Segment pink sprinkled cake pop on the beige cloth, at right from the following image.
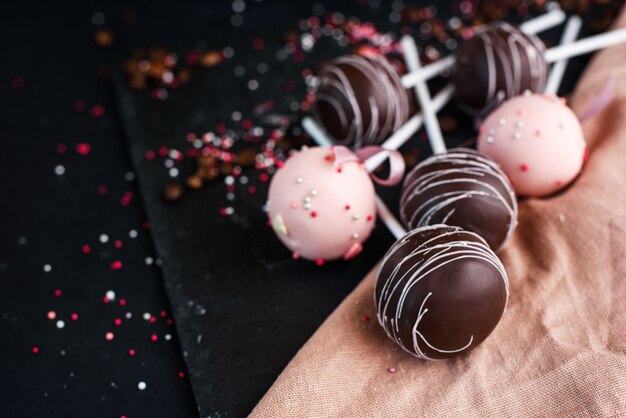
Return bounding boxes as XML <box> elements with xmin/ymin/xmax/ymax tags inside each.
<box><xmin>478</xmin><ymin>94</ymin><xmax>587</xmax><ymax>196</ymax></box>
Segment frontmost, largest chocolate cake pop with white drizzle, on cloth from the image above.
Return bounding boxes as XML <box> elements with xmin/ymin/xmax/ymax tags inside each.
<box><xmin>374</xmin><ymin>225</ymin><xmax>509</xmax><ymax>360</ymax></box>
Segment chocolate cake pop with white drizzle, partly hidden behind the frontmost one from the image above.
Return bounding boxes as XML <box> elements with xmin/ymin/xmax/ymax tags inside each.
<box><xmin>400</xmin><ymin>148</ymin><xmax>517</xmax><ymax>251</ymax></box>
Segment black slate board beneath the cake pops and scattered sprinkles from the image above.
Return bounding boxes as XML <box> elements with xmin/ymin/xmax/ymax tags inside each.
<box><xmin>115</xmin><ymin>2</ymin><xmax>582</xmax><ymax>417</ymax></box>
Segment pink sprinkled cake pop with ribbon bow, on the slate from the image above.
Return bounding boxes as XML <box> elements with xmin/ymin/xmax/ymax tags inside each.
<box><xmin>268</xmin><ymin>147</ymin><xmax>376</xmax><ymax>261</ymax></box>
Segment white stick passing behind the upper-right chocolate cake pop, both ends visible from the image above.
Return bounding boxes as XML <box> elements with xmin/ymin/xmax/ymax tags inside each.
<box><xmin>402</xmin><ymin>8</ymin><xmax>565</xmax><ymax>89</ymax></box>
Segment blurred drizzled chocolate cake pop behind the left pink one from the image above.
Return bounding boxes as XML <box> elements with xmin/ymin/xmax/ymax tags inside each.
<box><xmin>313</xmin><ymin>55</ymin><xmax>412</xmax><ymax>148</ymax></box>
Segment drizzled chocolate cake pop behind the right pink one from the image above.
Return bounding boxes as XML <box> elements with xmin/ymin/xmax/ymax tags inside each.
<box><xmin>452</xmin><ymin>22</ymin><xmax>548</xmax><ymax>116</ymax></box>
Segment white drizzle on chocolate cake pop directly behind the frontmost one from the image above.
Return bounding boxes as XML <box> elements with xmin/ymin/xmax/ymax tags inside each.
<box><xmin>400</xmin><ymin>148</ymin><xmax>518</xmax><ymax>250</ymax></box>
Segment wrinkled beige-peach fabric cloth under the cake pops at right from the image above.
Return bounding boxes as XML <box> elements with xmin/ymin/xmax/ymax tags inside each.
<box><xmin>252</xmin><ymin>12</ymin><xmax>626</xmax><ymax>417</ymax></box>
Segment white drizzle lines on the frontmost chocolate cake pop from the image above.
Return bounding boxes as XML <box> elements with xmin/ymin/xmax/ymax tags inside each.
<box><xmin>375</xmin><ymin>225</ymin><xmax>509</xmax><ymax>360</ymax></box>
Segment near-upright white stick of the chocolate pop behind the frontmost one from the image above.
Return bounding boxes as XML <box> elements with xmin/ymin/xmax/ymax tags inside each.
<box><xmin>400</xmin><ymin>36</ymin><xmax>446</xmax><ymax>154</ymax></box>
